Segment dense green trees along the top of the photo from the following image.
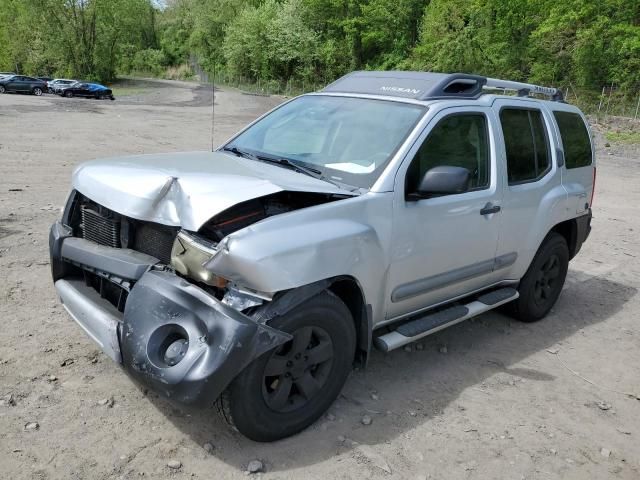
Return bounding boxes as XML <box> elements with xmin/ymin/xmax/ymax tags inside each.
<box><xmin>0</xmin><ymin>0</ymin><xmax>640</xmax><ymax>89</ymax></box>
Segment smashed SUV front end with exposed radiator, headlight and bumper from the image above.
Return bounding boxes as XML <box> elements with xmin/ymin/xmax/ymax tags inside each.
<box><xmin>50</xmin><ymin>192</ymin><xmax>308</xmax><ymax>405</ymax></box>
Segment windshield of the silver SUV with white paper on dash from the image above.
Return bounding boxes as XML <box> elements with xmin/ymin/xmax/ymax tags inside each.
<box><xmin>226</xmin><ymin>95</ymin><xmax>426</xmax><ymax>188</ymax></box>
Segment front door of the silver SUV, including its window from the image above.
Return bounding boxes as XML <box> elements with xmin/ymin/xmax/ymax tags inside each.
<box><xmin>387</xmin><ymin>107</ymin><xmax>510</xmax><ymax>319</ymax></box>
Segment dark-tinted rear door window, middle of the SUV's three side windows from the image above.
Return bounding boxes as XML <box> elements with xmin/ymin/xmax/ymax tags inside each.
<box><xmin>500</xmin><ymin>107</ymin><xmax>551</xmax><ymax>185</ymax></box>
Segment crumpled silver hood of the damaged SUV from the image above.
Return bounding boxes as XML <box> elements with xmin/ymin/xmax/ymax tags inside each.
<box><xmin>73</xmin><ymin>152</ymin><xmax>353</xmax><ymax>231</ymax></box>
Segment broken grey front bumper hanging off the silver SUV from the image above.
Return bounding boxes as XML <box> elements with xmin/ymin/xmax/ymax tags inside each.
<box><xmin>49</xmin><ymin>222</ymin><xmax>291</xmax><ymax>406</ymax></box>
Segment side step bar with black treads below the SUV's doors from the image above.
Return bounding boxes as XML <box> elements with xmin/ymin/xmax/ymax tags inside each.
<box><xmin>373</xmin><ymin>287</ymin><xmax>520</xmax><ymax>352</ymax></box>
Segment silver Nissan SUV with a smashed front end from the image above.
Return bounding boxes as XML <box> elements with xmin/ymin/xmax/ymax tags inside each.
<box><xmin>50</xmin><ymin>72</ymin><xmax>595</xmax><ymax>441</ymax></box>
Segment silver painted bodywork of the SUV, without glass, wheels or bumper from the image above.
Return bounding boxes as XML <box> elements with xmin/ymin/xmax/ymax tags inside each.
<box><xmin>73</xmin><ymin>93</ymin><xmax>595</xmax><ymax>328</ymax></box>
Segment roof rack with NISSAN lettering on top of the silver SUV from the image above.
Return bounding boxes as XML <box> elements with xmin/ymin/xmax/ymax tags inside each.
<box><xmin>322</xmin><ymin>71</ymin><xmax>563</xmax><ymax>101</ymax></box>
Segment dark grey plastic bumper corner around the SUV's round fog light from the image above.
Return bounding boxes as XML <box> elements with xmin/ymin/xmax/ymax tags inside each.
<box><xmin>121</xmin><ymin>270</ymin><xmax>292</xmax><ymax>407</ymax></box>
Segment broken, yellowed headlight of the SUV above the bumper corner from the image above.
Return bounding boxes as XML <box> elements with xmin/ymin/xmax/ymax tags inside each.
<box><xmin>171</xmin><ymin>230</ymin><xmax>227</xmax><ymax>288</ymax></box>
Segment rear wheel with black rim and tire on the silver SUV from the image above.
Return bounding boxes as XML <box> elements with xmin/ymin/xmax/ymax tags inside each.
<box><xmin>511</xmin><ymin>232</ymin><xmax>569</xmax><ymax>322</ymax></box>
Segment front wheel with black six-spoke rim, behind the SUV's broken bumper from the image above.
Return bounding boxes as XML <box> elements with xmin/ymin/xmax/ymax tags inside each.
<box><xmin>217</xmin><ymin>291</ymin><xmax>356</xmax><ymax>442</ymax></box>
